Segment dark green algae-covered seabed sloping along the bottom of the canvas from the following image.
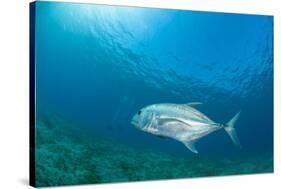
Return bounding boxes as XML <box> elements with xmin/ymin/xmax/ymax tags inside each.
<box><xmin>35</xmin><ymin>115</ymin><xmax>273</xmax><ymax>187</ymax></box>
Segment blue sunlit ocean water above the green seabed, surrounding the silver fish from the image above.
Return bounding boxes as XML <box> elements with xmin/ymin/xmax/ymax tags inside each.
<box><xmin>32</xmin><ymin>2</ymin><xmax>273</xmax><ymax>185</ymax></box>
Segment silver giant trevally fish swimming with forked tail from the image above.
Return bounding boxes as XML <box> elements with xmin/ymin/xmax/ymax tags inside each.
<box><xmin>131</xmin><ymin>102</ymin><xmax>241</xmax><ymax>153</ymax></box>
